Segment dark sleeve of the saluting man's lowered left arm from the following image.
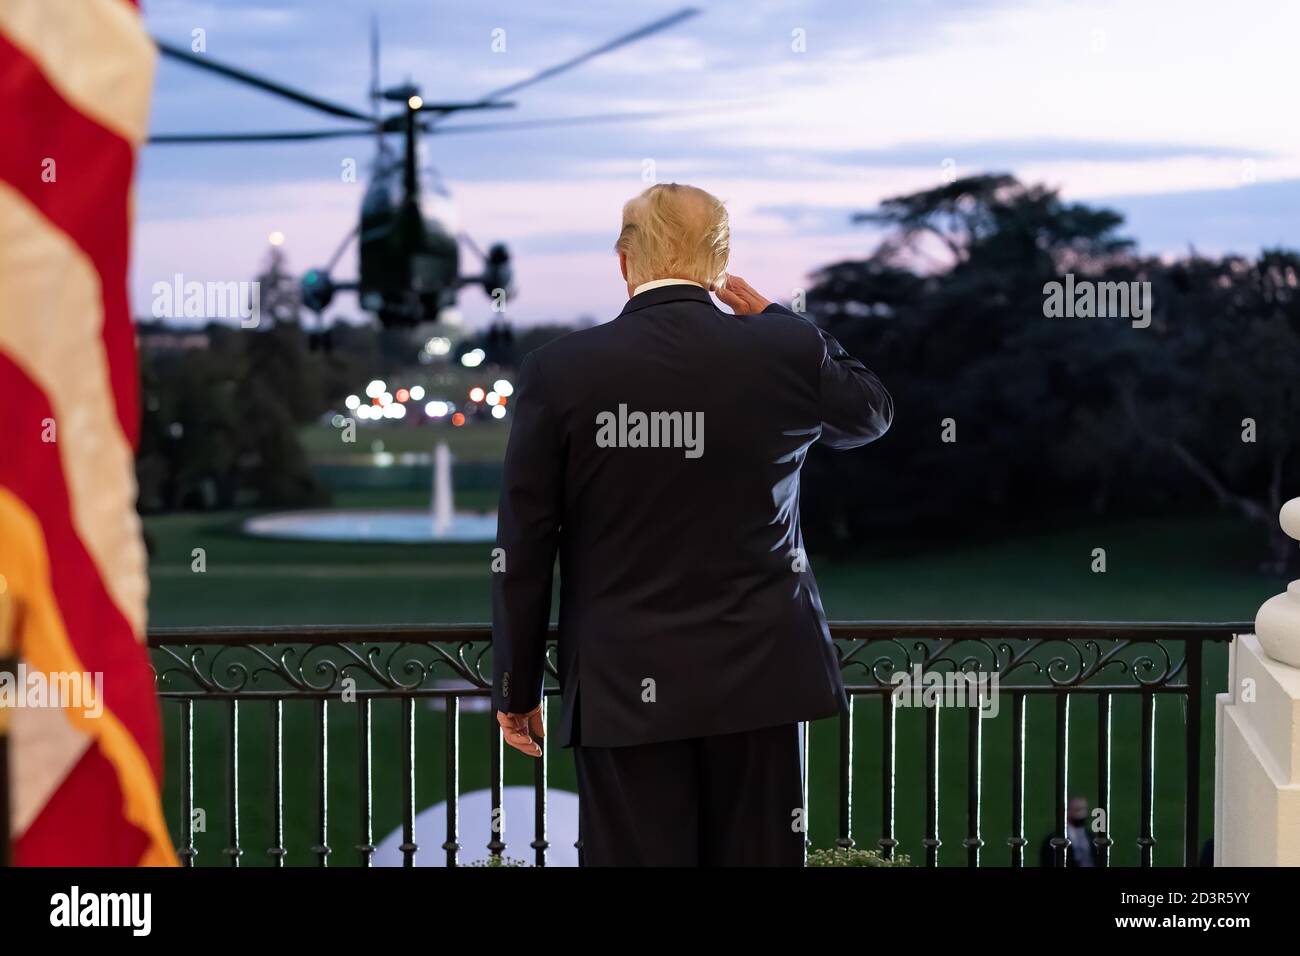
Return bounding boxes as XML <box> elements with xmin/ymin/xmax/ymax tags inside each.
<box><xmin>491</xmin><ymin>354</ymin><xmax>564</xmax><ymax>714</ymax></box>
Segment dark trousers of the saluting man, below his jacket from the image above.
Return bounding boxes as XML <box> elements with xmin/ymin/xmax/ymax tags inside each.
<box><xmin>573</xmin><ymin>723</ymin><xmax>805</xmax><ymax>866</ymax></box>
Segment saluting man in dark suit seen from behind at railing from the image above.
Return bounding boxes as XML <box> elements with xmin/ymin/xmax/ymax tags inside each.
<box><xmin>493</xmin><ymin>183</ymin><xmax>893</xmax><ymax>865</ymax></box>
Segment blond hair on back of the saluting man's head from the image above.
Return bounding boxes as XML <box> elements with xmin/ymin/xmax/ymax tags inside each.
<box><xmin>614</xmin><ymin>182</ymin><xmax>731</xmax><ymax>289</ymax></box>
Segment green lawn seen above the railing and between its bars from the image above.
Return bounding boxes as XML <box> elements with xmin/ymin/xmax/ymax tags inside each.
<box><xmin>146</xmin><ymin>476</ymin><xmax>1282</xmax><ymax>865</ymax></box>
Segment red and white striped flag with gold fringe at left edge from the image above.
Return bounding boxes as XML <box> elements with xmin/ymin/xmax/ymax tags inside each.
<box><xmin>0</xmin><ymin>0</ymin><xmax>176</xmax><ymax>865</ymax></box>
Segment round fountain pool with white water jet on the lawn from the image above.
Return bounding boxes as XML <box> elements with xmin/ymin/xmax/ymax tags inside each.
<box><xmin>243</xmin><ymin>441</ymin><xmax>497</xmax><ymax>544</ymax></box>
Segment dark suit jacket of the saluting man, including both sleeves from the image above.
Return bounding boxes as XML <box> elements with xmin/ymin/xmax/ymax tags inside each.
<box><xmin>493</xmin><ymin>285</ymin><xmax>893</xmax><ymax>747</ymax></box>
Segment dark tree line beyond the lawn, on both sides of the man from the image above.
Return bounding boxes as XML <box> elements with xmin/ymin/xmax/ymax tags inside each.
<box><xmin>138</xmin><ymin>174</ymin><xmax>1300</xmax><ymax>570</ymax></box>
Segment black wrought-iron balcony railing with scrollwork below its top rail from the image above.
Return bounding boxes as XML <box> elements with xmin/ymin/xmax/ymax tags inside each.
<box><xmin>137</xmin><ymin>622</ymin><xmax>1252</xmax><ymax>866</ymax></box>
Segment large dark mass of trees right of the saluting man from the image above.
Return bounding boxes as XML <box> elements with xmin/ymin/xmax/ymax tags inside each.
<box><xmin>803</xmin><ymin>174</ymin><xmax>1300</xmax><ymax>567</ymax></box>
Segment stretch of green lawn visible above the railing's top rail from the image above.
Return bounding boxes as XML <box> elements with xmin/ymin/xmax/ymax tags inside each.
<box><xmin>146</xmin><ymin>512</ymin><xmax>1281</xmax><ymax>626</ymax></box>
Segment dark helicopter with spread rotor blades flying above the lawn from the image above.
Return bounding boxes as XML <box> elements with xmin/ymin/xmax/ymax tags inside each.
<box><xmin>148</xmin><ymin>7</ymin><xmax>699</xmax><ymax>328</ymax></box>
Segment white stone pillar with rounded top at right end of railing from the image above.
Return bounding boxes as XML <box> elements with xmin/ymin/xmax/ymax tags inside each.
<box><xmin>1214</xmin><ymin>498</ymin><xmax>1300</xmax><ymax>866</ymax></box>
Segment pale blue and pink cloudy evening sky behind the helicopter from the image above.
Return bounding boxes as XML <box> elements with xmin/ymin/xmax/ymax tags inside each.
<box><xmin>131</xmin><ymin>0</ymin><xmax>1300</xmax><ymax>329</ymax></box>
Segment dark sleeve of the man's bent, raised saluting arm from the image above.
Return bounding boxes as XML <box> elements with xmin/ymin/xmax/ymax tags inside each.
<box><xmin>764</xmin><ymin>302</ymin><xmax>893</xmax><ymax>449</ymax></box>
